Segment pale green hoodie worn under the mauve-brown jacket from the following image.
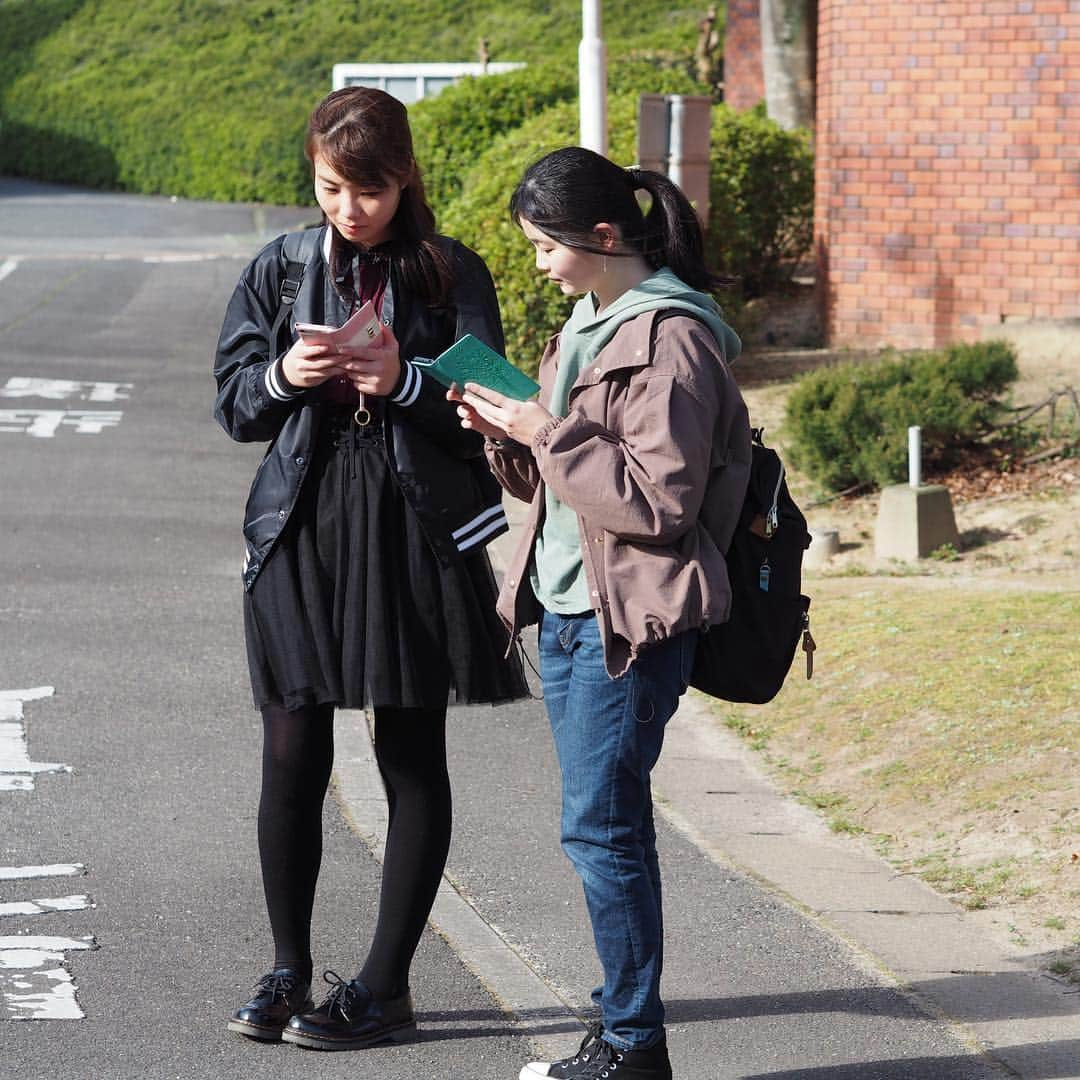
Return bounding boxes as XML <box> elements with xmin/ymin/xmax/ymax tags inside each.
<box><xmin>529</xmin><ymin>267</ymin><xmax>742</xmax><ymax>615</ymax></box>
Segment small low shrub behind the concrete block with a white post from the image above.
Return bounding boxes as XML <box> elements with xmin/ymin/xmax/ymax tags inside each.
<box><xmin>786</xmin><ymin>341</ymin><xmax>1017</xmax><ymax>490</ymax></box>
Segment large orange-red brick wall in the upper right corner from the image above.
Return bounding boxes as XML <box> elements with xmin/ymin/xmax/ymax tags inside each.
<box><xmin>816</xmin><ymin>0</ymin><xmax>1080</xmax><ymax>348</ymax></box>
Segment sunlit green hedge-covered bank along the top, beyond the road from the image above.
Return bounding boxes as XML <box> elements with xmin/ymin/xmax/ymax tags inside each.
<box><xmin>0</xmin><ymin>0</ymin><xmax>700</xmax><ymax>203</ymax></box>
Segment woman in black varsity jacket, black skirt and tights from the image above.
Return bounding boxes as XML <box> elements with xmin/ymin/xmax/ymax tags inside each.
<box><xmin>214</xmin><ymin>86</ymin><xmax>527</xmax><ymax>1050</ymax></box>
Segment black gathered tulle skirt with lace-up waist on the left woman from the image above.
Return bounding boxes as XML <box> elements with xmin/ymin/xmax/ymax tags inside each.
<box><xmin>244</xmin><ymin>253</ymin><xmax>528</xmax><ymax>710</ymax></box>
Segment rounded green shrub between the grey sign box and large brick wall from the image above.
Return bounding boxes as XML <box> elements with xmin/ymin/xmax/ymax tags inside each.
<box><xmin>708</xmin><ymin>105</ymin><xmax>813</xmax><ymax>297</ymax></box>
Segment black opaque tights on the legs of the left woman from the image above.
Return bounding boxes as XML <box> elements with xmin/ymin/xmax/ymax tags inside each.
<box><xmin>258</xmin><ymin>705</ymin><xmax>450</xmax><ymax>999</ymax></box>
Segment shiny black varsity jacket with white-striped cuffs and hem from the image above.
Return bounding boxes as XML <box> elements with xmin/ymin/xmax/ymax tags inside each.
<box><xmin>214</xmin><ymin>227</ymin><xmax>509</xmax><ymax>589</ymax></box>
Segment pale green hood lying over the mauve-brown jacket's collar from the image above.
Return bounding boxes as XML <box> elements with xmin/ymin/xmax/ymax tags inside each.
<box><xmin>565</xmin><ymin>267</ymin><xmax>742</xmax><ymax>364</ymax></box>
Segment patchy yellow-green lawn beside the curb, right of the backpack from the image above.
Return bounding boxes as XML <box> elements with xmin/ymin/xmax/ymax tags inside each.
<box><xmin>714</xmin><ymin>578</ymin><xmax>1080</xmax><ymax>915</ymax></box>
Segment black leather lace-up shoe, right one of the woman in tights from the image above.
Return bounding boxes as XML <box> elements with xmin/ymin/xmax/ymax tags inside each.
<box><xmin>281</xmin><ymin>971</ymin><xmax>416</xmax><ymax>1050</ymax></box>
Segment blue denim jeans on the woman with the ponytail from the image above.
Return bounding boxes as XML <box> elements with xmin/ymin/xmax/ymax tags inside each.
<box><xmin>540</xmin><ymin>611</ymin><xmax>697</xmax><ymax>1050</ymax></box>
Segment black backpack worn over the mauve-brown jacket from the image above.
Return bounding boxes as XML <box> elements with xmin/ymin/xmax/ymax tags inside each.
<box><xmin>690</xmin><ymin>428</ymin><xmax>814</xmax><ymax>704</ymax></box>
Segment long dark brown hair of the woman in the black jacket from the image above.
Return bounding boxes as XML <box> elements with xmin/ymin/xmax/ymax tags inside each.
<box><xmin>303</xmin><ymin>86</ymin><xmax>450</xmax><ymax>305</ymax></box>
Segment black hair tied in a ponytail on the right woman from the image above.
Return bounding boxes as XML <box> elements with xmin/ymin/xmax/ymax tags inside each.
<box><xmin>510</xmin><ymin>146</ymin><xmax>725</xmax><ymax>292</ymax></box>
